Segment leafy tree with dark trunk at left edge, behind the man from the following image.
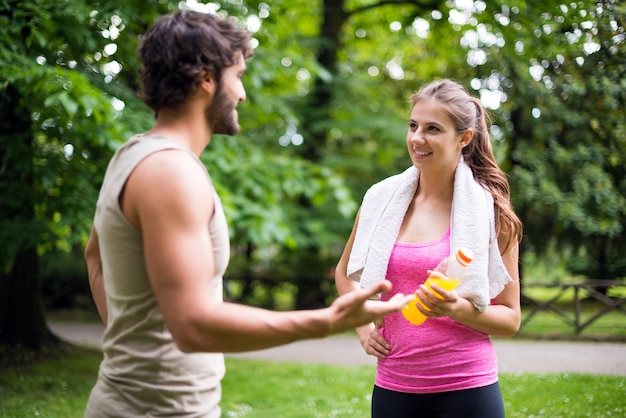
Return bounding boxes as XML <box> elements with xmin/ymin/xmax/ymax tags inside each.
<box><xmin>0</xmin><ymin>0</ymin><xmax>150</xmax><ymax>348</ymax></box>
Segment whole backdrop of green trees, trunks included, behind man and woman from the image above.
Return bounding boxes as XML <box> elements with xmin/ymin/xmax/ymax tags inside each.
<box><xmin>0</xmin><ymin>0</ymin><xmax>626</xmax><ymax>348</ymax></box>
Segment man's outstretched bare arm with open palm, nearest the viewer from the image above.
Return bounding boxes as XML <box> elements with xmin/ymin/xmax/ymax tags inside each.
<box><xmin>122</xmin><ymin>151</ymin><xmax>412</xmax><ymax>352</ymax></box>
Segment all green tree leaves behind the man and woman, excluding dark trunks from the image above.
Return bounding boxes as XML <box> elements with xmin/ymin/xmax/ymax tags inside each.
<box><xmin>0</xmin><ymin>0</ymin><xmax>626</xmax><ymax>284</ymax></box>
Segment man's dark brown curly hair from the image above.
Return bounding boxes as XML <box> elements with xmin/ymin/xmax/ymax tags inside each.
<box><xmin>139</xmin><ymin>10</ymin><xmax>252</xmax><ymax>112</ymax></box>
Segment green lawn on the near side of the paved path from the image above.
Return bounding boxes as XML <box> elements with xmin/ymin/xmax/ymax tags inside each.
<box><xmin>0</xmin><ymin>347</ymin><xmax>626</xmax><ymax>418</ymax></box>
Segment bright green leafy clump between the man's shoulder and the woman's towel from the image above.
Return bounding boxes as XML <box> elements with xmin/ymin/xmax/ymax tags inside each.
<box><xmin>202</xmin><ymin>137</ymin><xmax>356</xmax><ymax>260</ymax></box>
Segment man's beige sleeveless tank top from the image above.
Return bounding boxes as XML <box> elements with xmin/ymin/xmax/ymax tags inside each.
<box><xmin>85</xmin><ymin>135</ymin><xmax>230</xmax><ymax>418</ymax></box>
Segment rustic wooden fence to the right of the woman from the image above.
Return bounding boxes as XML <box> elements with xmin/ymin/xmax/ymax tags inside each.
<box><xmin>521</xmin><ymin>280</ymin><xmax>626</xmax><ymax>334</ymax></box>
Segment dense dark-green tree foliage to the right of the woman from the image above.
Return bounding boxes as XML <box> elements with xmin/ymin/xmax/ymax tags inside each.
<box><xmin>474</xmin><ymin>0</ymin><xmax>626</xmax><ymax>279</ymax></box>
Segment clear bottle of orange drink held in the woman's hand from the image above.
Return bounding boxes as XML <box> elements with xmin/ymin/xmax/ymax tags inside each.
<box><xmin>402</xmin><ymin>247</ymin><xmax>474</xmax><ymax>325</ymax></box>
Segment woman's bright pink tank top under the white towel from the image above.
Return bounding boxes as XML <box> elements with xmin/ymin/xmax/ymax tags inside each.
<box><xmin>376</xmin><ymin>229</ymin><xmax>498</xmax><ymax>393</ymax></box>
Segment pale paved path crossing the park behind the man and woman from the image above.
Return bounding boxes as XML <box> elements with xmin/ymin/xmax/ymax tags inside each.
<box><xmin>49</xmin><ymin>321</ymin><xmax>626</xmax><ymax>376</ymax></box>
